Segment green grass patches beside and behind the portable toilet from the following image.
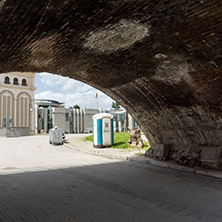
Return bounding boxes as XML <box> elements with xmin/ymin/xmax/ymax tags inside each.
<box><xmin>84</xmin><ymin>132</ymin><xmax>149</xmax><ymax>150</ymax></box>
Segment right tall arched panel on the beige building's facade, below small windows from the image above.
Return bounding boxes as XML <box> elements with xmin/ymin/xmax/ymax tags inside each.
<box><xmin>16</xmin><ymin>92</ymin><xmax>32</xmax><ymax>127</ymax></box>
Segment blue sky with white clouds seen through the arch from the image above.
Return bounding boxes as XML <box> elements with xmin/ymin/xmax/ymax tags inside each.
<box><xmin>35</xmin><ymin>72</ymin><xmax>114</xmax><ymax>110</ymax></box>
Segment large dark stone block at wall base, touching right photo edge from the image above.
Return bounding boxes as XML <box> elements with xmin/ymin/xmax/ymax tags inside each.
<box><xmin>200</xmin><ymin>147</ymin><xmax>222</xmax><ymax>168</ymax></box>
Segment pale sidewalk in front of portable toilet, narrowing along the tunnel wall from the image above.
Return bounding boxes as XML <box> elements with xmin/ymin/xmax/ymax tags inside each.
<box><xmin>65</xmin><ymin>134</ymin><xmax>222</xmax><ymax>179</ymax></box>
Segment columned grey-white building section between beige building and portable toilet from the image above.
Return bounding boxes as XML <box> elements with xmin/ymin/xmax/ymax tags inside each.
<box><xmin>34</xmin><ymin>100</ymin><xmax>99</xmax><ymax>133</ymax></box>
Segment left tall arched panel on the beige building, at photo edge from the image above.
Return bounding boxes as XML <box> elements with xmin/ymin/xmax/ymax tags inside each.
<box><xmin>0</xmin><ymin>90</ymin><xmax>15</xmax><ymax>127</ymax></box>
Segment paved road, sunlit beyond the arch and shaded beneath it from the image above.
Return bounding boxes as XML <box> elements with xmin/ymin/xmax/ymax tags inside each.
<box><xmin>0</xmin><ymin>136</ymin><xmax>222</xmax><ymax>222</ymax></box>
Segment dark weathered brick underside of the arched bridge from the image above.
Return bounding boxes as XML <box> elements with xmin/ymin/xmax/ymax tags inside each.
<box><xmin>0</xmin><ymin>0</ymin><xmax>222</xmax><ymax>149</ymax></box>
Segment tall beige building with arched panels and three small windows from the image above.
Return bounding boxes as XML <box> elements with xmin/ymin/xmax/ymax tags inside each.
<box><xmin>0</xmin><ymin>72</ymin><xmax>36</xmax><ymax>132</ymax></box>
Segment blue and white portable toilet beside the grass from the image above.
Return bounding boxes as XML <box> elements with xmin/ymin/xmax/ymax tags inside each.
<box><xmin>92</xmin><ymin>113</ymin><xmax>114</xmax><ymax>148</ymax></box>
